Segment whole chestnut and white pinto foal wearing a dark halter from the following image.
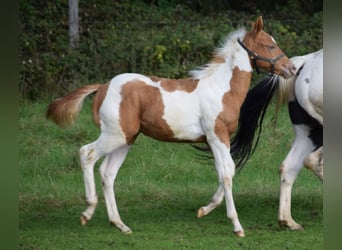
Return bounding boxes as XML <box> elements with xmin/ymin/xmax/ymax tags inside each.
<box><xmin>46</xmin><ymin>17</ymin><xmax>295</xmax><ymax>237</ymax></box>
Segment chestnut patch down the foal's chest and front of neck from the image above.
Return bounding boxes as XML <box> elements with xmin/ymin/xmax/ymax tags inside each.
<box><xmin>215</xmin><ymin>67</ymin><xmax>252</xmax><ymax>146</ymax></box>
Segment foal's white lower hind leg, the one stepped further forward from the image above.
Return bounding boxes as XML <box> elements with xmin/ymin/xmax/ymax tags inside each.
<box><xmin>100</xmin><ymin>145</ymin><xmax>132</xmax><ymax>234</ymax></box>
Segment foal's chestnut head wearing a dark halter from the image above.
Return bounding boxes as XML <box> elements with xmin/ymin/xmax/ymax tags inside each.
<box><xmin>238</xmin><ymin>16</ymin><xmax>296</xmax><ymax>78</ymax></box>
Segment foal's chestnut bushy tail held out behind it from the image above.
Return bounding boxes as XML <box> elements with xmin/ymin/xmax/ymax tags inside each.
<box><xmin>46</xmin><ymin>84</ymin><xmax>103</xmax><ymax>127</ymax></box>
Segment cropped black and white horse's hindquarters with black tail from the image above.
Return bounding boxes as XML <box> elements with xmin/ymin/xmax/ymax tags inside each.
<box><xmin>226</xmin><ymin>49</ymin><xmax>323</xmax><ymax>230</ymax></box>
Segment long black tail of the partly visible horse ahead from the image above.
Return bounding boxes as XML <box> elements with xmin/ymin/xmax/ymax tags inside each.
<box><xmin>230</xmin><ymin>75</ymin><xmax>279</xmax><ymax>168</ymax></box>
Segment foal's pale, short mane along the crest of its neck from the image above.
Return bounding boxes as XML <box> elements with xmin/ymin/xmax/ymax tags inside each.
<box><xmin>189</xmin><ymin>27</ymin><xmax>246</xmax><ymax>80</ymax></box>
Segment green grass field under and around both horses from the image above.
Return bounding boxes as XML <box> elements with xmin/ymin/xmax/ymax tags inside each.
<box><xmin>19</xmin><ymin>101</ymin><xmax>323</xmax><ymax>250</ymax></box>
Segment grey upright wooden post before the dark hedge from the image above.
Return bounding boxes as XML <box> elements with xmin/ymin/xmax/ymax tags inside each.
<box><xmin>69</xmin><ymin>0</ymin><xmax>80</xmax><ymax>49</ymax></box>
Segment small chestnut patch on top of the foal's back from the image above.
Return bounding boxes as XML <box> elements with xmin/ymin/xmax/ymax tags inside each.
<box><xmin>150</xmin><ymin>76</ymin><xmax>198</xmax><ymax>93</ymax></box>
